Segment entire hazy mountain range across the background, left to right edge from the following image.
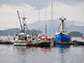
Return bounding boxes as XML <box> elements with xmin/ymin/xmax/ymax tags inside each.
<box><xmin>0</xmin><ymin>19</ymin><xmax>84</xmax><ymax>36</ymax></box>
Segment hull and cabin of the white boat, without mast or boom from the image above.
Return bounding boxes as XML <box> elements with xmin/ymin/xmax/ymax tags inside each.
<box><xmin>14</xmin><ymin>32</ymin><xmax>31</xmax><ymax>46</ymax></box>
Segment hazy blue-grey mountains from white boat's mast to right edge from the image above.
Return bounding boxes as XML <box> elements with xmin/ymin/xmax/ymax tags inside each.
<box><xmin>28</xmin><ymin>19</ymin><xmax>84</xmax><ymax>36</ymax></box>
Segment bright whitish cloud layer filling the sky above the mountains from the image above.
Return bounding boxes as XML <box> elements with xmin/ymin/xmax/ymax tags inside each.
<box><xmin>0</xmin><ymin>0</ymin><xmax>84</xmax><ymax>29</ymax></box>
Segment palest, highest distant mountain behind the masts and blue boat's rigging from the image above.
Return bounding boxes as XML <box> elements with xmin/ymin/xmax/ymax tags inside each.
<box><xmin>28</xmin><ymin>19</ymin><xmax>75</xmax><ymax>36</ymax></box>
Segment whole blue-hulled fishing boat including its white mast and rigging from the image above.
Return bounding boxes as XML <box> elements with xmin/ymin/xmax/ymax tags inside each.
<box><xmin>54</xmin><ymin>16</ymin><xmax>71</xmax><ymax>42</ymax></box>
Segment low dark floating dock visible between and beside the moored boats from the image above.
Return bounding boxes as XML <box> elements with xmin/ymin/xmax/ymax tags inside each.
<box><xmin>0</xmin><ymin>41</ymin><xmax>84</xmax><ymax>47</ymax></box>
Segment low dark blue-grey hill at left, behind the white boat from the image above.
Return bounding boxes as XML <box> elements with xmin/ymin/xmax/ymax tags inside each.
<box><xmin>0</xmin><ymin>28</ymin><xmax>41</xmax><ymax>36</ymax></box>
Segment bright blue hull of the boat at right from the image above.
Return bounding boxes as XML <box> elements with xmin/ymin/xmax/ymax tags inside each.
<box><xmin>55</xmin><ymin>34</ymin><xmax>71</xmax><ymax>42</ymax></box>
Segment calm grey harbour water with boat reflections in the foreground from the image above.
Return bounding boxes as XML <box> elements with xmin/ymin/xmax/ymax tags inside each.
<box><xmin>0</xmin><ymin>38</ymin><xmax>84</xmax><ymax>63</ymax></box>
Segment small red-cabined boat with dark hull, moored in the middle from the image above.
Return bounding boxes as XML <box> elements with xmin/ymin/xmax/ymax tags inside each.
<box><xmin>39</xmin><ymin>36</ymin><xmax>53</xmax><ymax>47</ymax></box>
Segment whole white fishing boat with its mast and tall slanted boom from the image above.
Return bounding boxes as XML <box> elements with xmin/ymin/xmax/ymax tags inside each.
<box><xmin>14</xmin><ymin>11</ymin><xmax>31</xmax><ymax>46</ymax></box>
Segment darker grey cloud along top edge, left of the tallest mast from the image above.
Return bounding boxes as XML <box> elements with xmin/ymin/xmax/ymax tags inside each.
<box><xmin>0</xmin><ymin>0</ymin><xmax>49</xmax><ymax>9</ymax></box>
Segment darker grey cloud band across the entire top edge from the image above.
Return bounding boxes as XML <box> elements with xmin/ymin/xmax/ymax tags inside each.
<box><xmin>0</xmin><ymin>0</ymin><xmax>84</xmax><ymax>9</ymax></box>
